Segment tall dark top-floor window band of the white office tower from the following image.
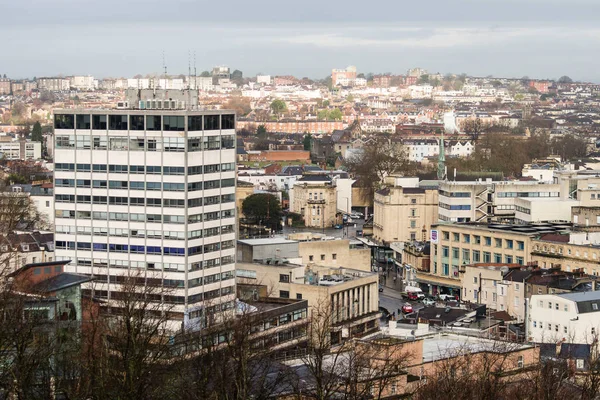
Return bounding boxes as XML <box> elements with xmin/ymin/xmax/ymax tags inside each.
<box><xmin>54</xmin><ymin>114</ymin><xmax>235</xmax><ymax>131</ymax></box>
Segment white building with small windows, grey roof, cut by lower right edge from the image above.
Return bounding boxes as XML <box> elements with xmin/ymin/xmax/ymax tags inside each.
<box><xmin>527</xmin><ymin>291</ymin><xmax>600</xmax><ymax>344</ymax></box>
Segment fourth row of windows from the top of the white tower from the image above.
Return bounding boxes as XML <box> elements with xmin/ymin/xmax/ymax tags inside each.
<box><xmin>54</xmin><ymin>178</ymin><xmax>235</xmax><ymax>191</ymax></box>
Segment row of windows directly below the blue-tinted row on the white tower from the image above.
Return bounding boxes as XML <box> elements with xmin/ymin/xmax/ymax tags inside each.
<box><xmin>66</xmin><ymin>256</ymin><xmax>235</xmax><ymax>272</ymax></box>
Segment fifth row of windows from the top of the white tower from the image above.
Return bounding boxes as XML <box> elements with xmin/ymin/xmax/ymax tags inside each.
<box><xmin>55</xmin><ymin>194</ymin><xmax>235</xmax><ymax>209</ymax></box>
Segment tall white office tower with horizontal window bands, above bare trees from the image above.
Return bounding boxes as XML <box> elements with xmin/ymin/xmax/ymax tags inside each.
<box><xmin>54</xmin><ymin>108</ymin><xmax>236</xmax><ymax>328</ymax></box>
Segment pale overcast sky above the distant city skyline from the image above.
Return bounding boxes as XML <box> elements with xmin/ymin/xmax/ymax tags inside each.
<box><xmin>0</xmin><ymin>0</ymin><xmax>600</xmax><ymax>82</ymax></box>
